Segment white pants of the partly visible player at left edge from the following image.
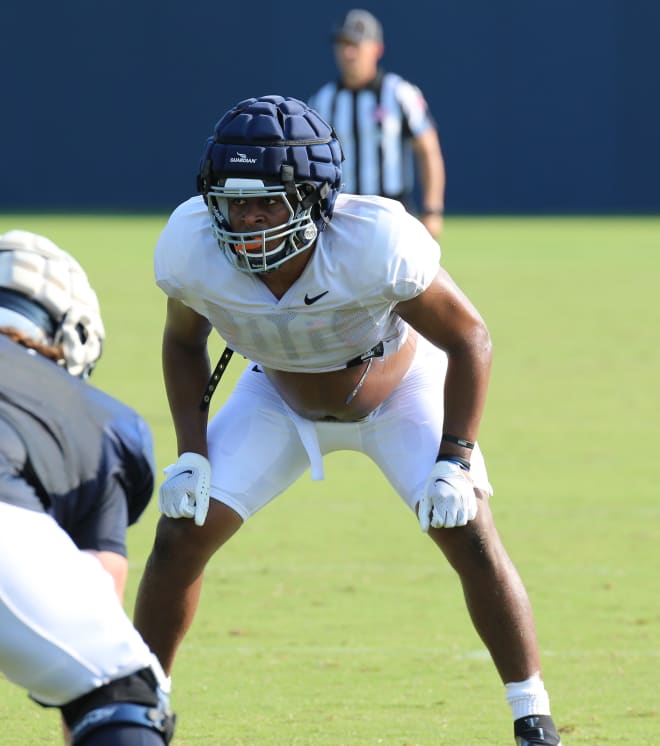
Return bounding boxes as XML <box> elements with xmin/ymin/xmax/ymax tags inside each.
<box><xmin>0</xmin><ymin>502</ymin><xmax>151</xmax><ymax>706</ymax></box>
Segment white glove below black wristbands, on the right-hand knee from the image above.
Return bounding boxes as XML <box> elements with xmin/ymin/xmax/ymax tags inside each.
<box><xmin>417</xmin><ymin>461</ymin><xmax>477</xmax><ymax>532</ymax></box>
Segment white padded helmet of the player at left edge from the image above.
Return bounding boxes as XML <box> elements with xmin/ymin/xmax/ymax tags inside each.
<box><xmin>0</xmin><ymin>230</ymin><xmax>105</xmax><ymax>377</ymax></box>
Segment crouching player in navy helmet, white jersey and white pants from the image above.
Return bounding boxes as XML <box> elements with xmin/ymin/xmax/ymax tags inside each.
<box><xmin>135</xmin><ymin>96</ymin><xmax>560</xmax><ymax>746</ymax></box>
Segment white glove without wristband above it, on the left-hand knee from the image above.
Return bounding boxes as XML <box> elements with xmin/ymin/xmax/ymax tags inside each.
<box><xmin>158</xmin><ymin>452</ymin><xmax>211</xmax><ymax>526</ymax></box>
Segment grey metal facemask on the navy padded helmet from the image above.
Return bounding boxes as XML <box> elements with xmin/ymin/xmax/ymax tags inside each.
<box><xmin>206</xmin><ymin>178</ymin><xmax>318</xmax><ymax>274</ymax></box>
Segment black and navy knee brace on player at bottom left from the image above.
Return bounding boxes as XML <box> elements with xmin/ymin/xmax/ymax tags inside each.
<box><xmin>61</xmin><ymin>668</ymin><xmax>175</xmax><ymax>746</ymax></box>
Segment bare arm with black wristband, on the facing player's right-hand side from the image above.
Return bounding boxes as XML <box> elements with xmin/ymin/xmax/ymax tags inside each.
<box><xmin>396</xmin><ymin>268</ymin><xmax>492</xmax><ymax>459</ymax></box>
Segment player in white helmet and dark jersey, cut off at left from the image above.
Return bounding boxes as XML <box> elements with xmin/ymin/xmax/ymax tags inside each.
<box><xmin>0</xmin><ymin>230</ymin><xmax>174</xmax><ymax>746</ymax></box>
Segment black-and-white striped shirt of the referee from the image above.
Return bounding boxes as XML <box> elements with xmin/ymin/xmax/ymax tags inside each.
<box><xmin>309</xmin><ymin>71</ymin><xmax>435</xmax><ymax>205</ymax></box>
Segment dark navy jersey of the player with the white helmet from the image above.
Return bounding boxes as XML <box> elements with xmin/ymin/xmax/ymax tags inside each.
<box><xmin>0</xmin><ymin>334</ymin><xmax>155</xmax><ymax>555</ymax></box>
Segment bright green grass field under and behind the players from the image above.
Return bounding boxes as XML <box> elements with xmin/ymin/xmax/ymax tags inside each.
<box><xmin>0</xmin><ymin>215</ymin><xmax>660</xmax><ymax>746</ymax></box>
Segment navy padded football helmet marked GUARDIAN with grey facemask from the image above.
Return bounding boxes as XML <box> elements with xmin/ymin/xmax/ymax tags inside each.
<box><xmin>197</xmin><ymin>96</ymin><xmax>344</xmax><ymax>273</ymax></box>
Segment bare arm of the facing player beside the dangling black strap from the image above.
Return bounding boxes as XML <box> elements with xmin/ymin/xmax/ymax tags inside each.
<box><xmin>162</xmin><ymin>298</ymin><xmax>211</xmax><ymax>456</ymax></box>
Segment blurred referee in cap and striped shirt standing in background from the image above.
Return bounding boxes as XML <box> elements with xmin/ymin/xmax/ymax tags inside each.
<box><xmin>309</xmin><ymin>10</ymin><xmax>445</xmax><ymax>238</ymax></box>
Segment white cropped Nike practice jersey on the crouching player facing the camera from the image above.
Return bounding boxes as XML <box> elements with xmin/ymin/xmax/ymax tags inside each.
<box><xmin>154</xmin><ymin>194</ymin><xmax>440</xmax><ymax>372</ymax></box>
